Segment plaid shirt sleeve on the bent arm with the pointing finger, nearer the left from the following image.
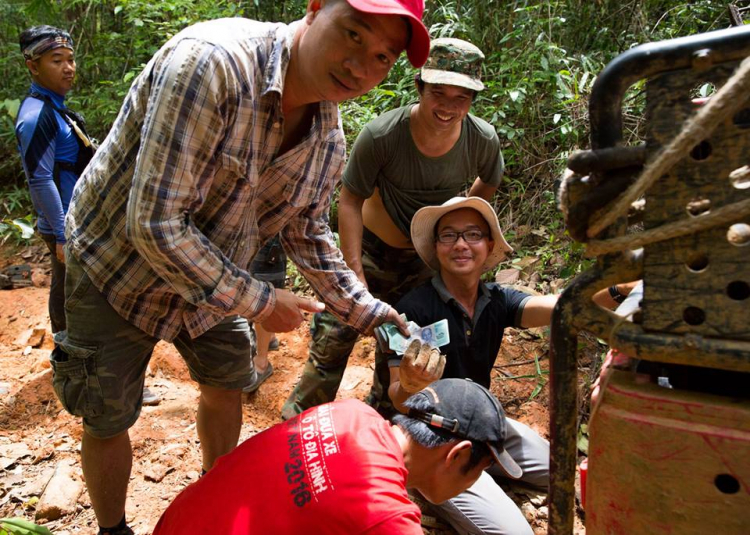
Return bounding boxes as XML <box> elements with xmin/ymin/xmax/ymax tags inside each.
<box><xmin>126</xmin><ymin>39</ymin><xmax>275</xmax><ymax>320</ymax></box>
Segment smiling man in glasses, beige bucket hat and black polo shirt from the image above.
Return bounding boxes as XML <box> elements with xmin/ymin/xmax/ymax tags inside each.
<box><xmin>378</xmin><ymin>197</ymin><xmax>627</xmax><ymax>535</ymax></box>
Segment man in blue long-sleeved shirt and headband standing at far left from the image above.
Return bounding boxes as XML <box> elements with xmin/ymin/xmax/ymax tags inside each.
<box><xmin>16</xmin><ymin>26</ymin><xmax>93</xmax><ymax>332</ymax></box>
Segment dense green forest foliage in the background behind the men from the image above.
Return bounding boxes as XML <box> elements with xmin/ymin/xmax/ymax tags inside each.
<box><xmin>0</xmin><ymin>0</ymin><xmax>728</xmax><ymax>278</ymax></box>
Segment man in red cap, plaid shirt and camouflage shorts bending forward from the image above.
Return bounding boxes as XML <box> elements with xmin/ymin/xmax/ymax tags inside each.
<box><xmin>52</xmin><ymin>0</ymin><xmax>429</xmax><ymax>535</ymax></box>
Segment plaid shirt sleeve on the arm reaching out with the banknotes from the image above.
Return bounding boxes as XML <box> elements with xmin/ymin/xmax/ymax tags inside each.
<box><xmin>282</xmin><ymin>153</ymin><xmax>390</xmax><ymax>332</ymax></box>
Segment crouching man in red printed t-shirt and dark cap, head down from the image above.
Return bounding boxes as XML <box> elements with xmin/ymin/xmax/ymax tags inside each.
<box><xmin>154</xmin><ymin>379</ymin><xmax>520</xmax><ymax>535</ymax></box>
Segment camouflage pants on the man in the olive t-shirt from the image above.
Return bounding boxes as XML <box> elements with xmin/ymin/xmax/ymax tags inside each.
<box><xmin>281</xmin><ymin>229</ymin><xmax>433</xmax><ymax>419</ymax></box>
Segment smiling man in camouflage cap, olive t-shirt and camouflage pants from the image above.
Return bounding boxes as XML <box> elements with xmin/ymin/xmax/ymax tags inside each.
<box><xmin>282</xmin><ymin>39</ymin><xmax>504</xmax><ymax>418</ymax></box>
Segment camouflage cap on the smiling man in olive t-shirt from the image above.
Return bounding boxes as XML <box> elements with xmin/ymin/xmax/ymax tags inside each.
<box><xmin>420</xmin><ymin>38</ymin><xmax>484</xmax><ymax>91</ymax></box>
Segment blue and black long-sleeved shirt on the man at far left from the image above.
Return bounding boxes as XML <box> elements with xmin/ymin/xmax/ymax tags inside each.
<box><xmin>16</xmin><ymin>83</ymin><xmax>78</xmax><ymax>243</ymax></box>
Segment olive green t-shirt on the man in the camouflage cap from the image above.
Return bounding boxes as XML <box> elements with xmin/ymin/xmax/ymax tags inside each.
<box><xmin>342</xmin><ymin>106</ymin><xmax>504</xmax><ymax>236</ymax></box>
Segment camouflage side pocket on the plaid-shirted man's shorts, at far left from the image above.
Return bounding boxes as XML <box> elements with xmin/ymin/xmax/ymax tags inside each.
<box><xmin>50</xmin><ymin>338</ymin><xmax>104</xmax><ymax>418</ymax></box>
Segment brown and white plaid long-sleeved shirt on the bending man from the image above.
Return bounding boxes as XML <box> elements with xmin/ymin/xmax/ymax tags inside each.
<box><xmin>66</xmin><ymin>18</ymin><xmax>388</xmax><ymax>340</ymax></box>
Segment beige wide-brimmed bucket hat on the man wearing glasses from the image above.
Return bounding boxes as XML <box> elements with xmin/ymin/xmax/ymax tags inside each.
<box><xmin>411</xmin><ymin>197</ymin><xmax>513</xmax><ymax>272</ymax></box>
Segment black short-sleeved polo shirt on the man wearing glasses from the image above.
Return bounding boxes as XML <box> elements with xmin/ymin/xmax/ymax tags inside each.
<box><xmin>388</xmin><ymin>275</ymin><xmax>531</xmax><ymax>388</ymax></box>
